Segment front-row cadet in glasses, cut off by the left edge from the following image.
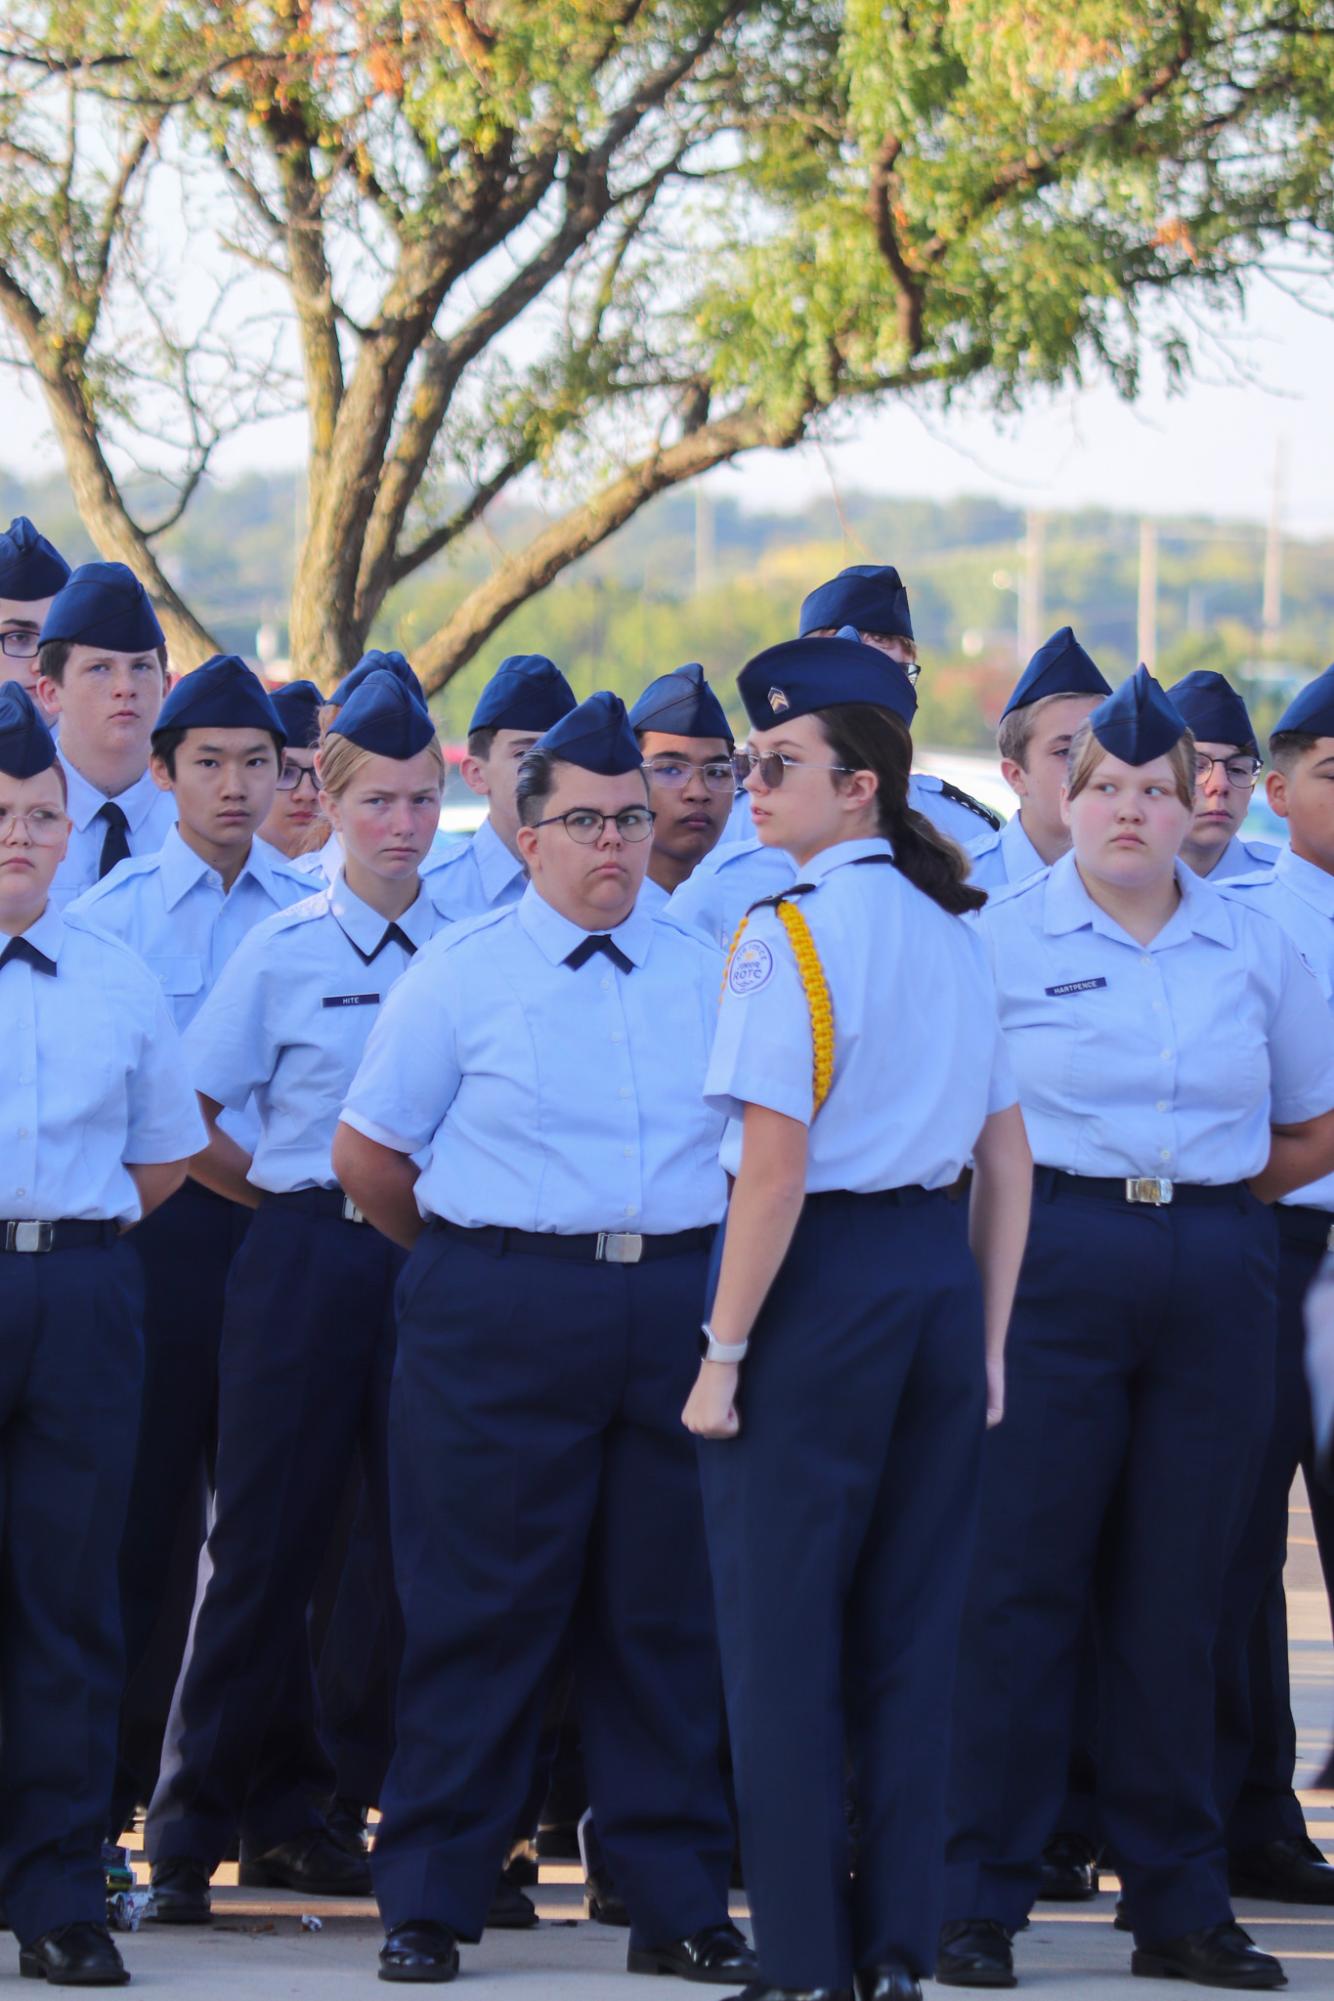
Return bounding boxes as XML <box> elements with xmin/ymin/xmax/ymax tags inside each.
<box><xmin>0</xmin><ymin>682</ymin><xmax>204</xmax><ymax>1987</ymax></box>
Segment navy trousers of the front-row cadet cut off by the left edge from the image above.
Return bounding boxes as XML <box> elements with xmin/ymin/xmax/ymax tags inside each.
<box><xmin>0</xmin><ymin>1241</ymin><xmax>144</xmax><ymax>1945</ymax></box>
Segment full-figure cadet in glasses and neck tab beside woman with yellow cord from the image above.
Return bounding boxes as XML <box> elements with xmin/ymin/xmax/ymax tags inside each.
<box><xmin>334</xmin><ymin>694</ymin><xmax>754</xmax><ymax>1983</ymax></box>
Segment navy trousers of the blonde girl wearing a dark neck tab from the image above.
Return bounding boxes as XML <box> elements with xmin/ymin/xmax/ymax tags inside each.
<box><xmin>146</xmin><ymin>1203</ymin><xmax>402</xmax><ymax>1869</ymax></box>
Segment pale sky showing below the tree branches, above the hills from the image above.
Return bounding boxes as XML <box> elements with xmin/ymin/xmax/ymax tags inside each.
<box><xmin>0</xmin><ymin>284</ymin><xmax>1334</xmax><ymax>536</ymax></box>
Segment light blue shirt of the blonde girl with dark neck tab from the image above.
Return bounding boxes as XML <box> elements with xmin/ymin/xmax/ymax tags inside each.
<box><xmin>186</xmin><ymin>874</ymin><xmax>446</xmax><ymax>1195</ymax></box>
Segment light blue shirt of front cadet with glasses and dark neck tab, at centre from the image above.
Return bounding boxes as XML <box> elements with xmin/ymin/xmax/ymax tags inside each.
<box><xmin>342</xmin><ymin>886</ymin><xmax>726</xmax><ymax>1237</ymax></box>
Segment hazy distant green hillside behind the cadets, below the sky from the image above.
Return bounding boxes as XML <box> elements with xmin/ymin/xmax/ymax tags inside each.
<box><xmin>0</xmin><ymin>472</ymin><xmax>1334</xmax><ymax>748</ymax></box>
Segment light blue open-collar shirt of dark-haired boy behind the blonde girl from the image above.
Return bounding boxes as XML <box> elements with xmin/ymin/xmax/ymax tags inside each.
<box><xmin>70</xmin><ymin>826</ymin><xmax>312</xmax><ymax>1029</ymax></box>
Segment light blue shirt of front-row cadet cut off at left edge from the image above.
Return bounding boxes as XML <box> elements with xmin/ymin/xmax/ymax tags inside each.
<box><xmin>0</xmin><ymin>904</ymin><xmax>206</xmax><ymax>1223</ymax></box>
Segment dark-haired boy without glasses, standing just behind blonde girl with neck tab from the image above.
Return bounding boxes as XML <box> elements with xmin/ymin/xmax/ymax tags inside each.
<box><xmin>70</xmin><ymin>652</ymin><xmax>310</xmax><ymax>1856</ymax></box>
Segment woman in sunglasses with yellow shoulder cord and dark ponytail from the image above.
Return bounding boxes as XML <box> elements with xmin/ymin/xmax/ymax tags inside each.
<box><xmin>684</xmin><ymin>636</ymin><xmax>1030</xmax><ymax>2001</ymax></box>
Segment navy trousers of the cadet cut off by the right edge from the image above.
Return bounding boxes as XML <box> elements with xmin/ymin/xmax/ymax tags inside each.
<box><xmin>1218</xmin><ymin>1207</ymin><xmax>1334</xmax><ymax>1853</ymax></box>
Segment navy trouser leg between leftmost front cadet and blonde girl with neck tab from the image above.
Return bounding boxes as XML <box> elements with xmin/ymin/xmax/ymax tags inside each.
<box><xmin>106</xmin><ymin>1181</ymin><xmax>250</xmax><ymax>1841</ymax></box>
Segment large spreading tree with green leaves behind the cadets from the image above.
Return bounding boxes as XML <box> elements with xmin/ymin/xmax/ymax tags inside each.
<box><xmin>0</xmin><ymin>0</ymin><xmax>1334</xmax><ymax>686</ymax></box>
